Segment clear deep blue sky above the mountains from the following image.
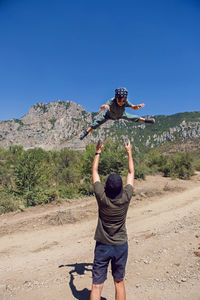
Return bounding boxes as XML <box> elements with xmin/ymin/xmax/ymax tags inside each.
<box><xmin>0</xmin><ymin>0</ymin><xmax>200</xmax><ymax>120</ymax></box>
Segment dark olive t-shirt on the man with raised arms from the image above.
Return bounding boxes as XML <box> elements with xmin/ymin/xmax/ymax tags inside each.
<box><xmin>94</xmin><ymin>181</ymin><xmax>133</xmax><ymax>245</ymax></box>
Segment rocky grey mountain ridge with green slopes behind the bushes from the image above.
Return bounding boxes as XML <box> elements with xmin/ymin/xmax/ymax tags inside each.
<box><xmin>0</xmin><ymin>101</ymin><xmax>200</xmax><ymax>151</ymax></box>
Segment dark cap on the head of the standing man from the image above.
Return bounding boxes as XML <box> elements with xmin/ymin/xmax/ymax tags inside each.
<box><xmin>105</xmin><ymin>173</ymin><xmax>123</xmax><ymax>199</ymax></box>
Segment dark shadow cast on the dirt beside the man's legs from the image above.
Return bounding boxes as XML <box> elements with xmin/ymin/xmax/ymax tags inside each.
<box><xmin>59</xmin><ymin>263</ymin><xmax>107</xmax><ymax>300</ymax></box>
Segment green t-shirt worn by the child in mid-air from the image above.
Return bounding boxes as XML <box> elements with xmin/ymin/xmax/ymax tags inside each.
<box><xmin>106</xmin><ymin>98</ymin><xmax>132</xmax><ymax>120</ymax></box>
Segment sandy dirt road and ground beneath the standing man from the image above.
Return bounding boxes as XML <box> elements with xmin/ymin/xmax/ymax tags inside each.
<box><xmin>0</xmin><ymin>173</ymin><xmax>200</xmax><ymax>300</ymax></box>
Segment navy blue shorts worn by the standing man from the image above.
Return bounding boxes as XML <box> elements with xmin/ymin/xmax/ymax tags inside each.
<box><xmin>92</xmin><ymin>242</ymin><xmax>128</xmax><ymax>284</ymax></box>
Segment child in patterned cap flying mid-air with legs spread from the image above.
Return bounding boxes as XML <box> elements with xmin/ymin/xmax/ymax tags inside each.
<box><xmin>80</xmin><ymin>88</ymin><xmax>155</xmax><ymax>140</ymax></box>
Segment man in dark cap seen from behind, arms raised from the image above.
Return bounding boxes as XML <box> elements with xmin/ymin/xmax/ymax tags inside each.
<box><xmin>90</xmin><ymin>141</ymin><xmax>134</xmax><ymax>300</ymax></box>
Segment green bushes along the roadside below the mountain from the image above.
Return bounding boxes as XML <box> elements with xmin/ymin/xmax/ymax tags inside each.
<box><xmin>0</xmin><ymin>139</ymin><xmax>200</xmax><ymax>214</ymax></box>
